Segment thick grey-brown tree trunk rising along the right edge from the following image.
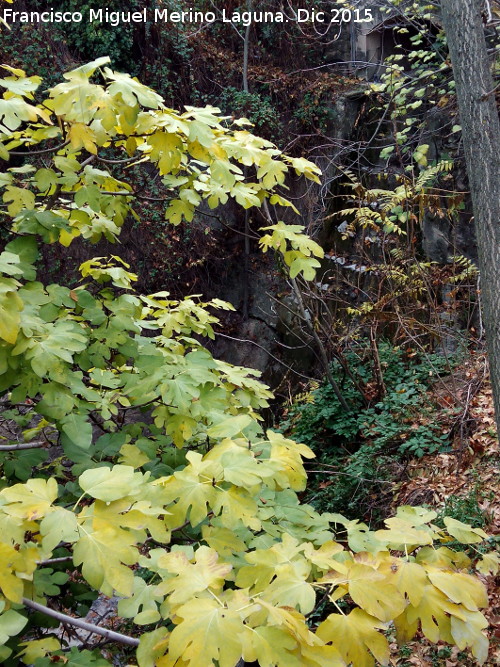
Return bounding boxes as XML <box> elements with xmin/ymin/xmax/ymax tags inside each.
<box><xmin>441</xmin><ymin>0</ymin><xmax>500</xmax><ymax>434</ymax></box>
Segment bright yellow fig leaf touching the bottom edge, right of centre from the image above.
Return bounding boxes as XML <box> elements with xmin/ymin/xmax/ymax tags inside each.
<box><xmin>316</xmin><ymin>609</ymin><xmax>389</xmax><ymax>667</ymax></box>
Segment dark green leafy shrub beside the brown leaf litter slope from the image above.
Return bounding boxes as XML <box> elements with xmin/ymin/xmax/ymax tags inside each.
<box><xmin>280</xmin><ymin>341</ymin><xmax>458</xmax><ymax>517</ymax></box>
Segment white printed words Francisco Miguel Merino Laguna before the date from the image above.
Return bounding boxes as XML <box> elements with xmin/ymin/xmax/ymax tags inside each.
<box><xmin>0</xmin><ymin>7</ymin><xmax>292</xmax><ymax>27</ymax></box>
